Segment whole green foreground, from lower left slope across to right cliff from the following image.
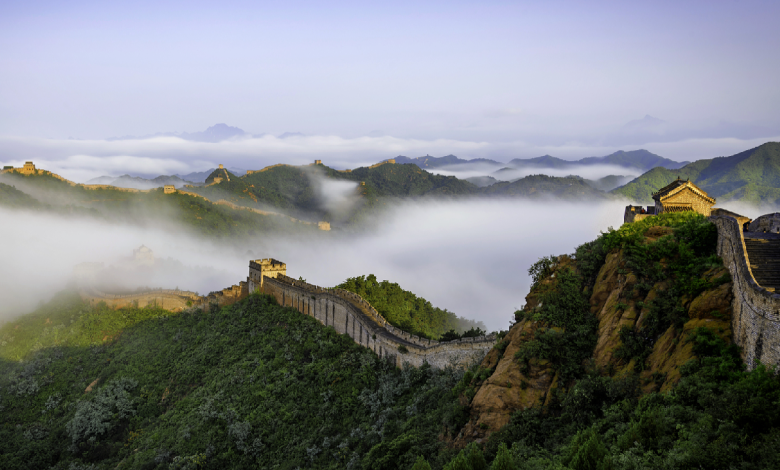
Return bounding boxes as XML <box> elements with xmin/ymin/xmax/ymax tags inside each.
<box><xmin>0</xmin><ymin>217</ymin><xmax>780</xmax><ymax>470</ymax></box>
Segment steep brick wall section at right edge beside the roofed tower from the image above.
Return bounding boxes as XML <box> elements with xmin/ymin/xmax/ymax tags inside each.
<box><xmin>709</xmin><ymin>216</ymin><xmax>780</xmax><ymax>369</ymax></box>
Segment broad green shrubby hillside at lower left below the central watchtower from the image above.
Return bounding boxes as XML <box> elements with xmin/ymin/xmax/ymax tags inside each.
<box><xmin>0</xmin><ymin>295</ymin><xmax>466</xmax><ymax>469</ymax></box>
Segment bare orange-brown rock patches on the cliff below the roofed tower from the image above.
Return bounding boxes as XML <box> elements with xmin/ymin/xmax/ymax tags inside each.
<box><xmin>454</xmin><ymin>227</ymin><xmax>733</xmax><ymax>447</ymax></box>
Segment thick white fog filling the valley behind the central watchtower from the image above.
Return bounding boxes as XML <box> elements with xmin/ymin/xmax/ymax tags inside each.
<box><xmin>0</xmin><ymin>200</ymin><xmax>764</xmax><ymax>330</ymax></box>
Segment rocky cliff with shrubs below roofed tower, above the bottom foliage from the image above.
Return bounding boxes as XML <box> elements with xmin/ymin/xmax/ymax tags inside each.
<box><xmin>454</xmin><ymin>217</ymin><xmax>732</xmax><ymax>447</ymax></box>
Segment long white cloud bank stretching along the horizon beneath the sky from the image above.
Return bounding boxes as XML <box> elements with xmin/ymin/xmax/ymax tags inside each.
<box><xmin>0</xmin><ymin>135</ymin><xmax>780</xmax><ymax>182</ymax></box>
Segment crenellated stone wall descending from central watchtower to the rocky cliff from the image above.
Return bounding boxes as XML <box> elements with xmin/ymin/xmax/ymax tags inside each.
<box><xmin>263</xmin><ymin>275</ymin><xmax>496</xmax><ymax>368</ymax></box>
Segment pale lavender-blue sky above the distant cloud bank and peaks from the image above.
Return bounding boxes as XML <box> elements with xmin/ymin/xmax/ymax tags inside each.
<box><xmin>0</xmin><ymin>1</ymin><xmax>780</xmax><ymax>175</ymax></box>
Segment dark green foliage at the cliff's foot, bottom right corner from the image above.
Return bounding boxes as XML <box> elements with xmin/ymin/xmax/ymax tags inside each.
<box><xmin>472</xmin><ymin>328</ymin><xmax>780</xmax><ymax>470</ymax></box>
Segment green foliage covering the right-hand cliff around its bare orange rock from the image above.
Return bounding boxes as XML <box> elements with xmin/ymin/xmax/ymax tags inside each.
<box><xmin>424</xmin><ymin>213</ymin><xmax>780</xmax><ymax>470</ymax></box>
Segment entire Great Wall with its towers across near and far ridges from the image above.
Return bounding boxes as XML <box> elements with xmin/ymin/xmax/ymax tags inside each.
<box><xmin>10</xmin><ymin>160</ymin><xmax>780</xmax><ymax>369</ymax></box>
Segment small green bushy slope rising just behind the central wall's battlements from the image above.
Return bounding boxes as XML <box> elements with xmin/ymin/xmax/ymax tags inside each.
<box><xmin>336</xmin><ymin>274</ymin><xmax>485</xmax><ymax>341</ymax></box>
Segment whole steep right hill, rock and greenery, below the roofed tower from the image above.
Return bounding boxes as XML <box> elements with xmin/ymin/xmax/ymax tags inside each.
<box><xmin>430</xmin><ymin>213</ymin><xmax>780</xmax><ymax>470</ymax></box>
